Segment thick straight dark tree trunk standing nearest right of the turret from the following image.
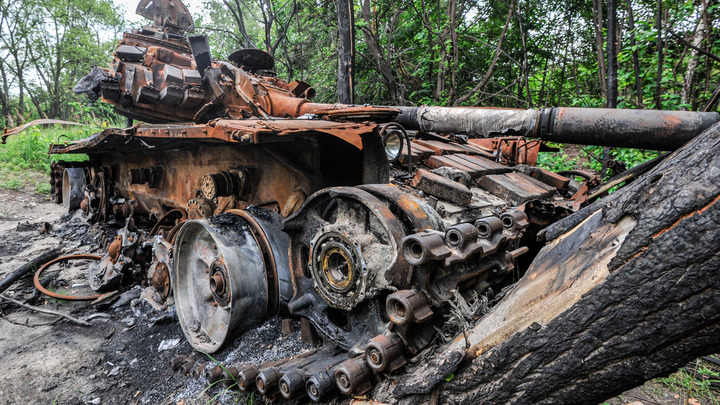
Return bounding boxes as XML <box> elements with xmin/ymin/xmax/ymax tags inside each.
<box><xmin>337</xmin><ymin>0</ymin><xmax>355</xmax><ymax>104</ymax></box>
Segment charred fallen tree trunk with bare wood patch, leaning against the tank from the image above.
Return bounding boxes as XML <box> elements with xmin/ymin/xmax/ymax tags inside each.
<box><xmin>374</xmin><ymin>124</ymin><xmax>720</xmax><ymax>404</ymax></box>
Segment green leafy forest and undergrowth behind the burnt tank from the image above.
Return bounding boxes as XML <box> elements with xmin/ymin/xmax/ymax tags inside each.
<box><xmin>0</xmin><ymin>0</ymin><xmax>720</xmax><ymax>185</ymax></box>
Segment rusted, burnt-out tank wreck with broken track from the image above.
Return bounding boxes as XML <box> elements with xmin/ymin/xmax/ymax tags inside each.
<box><xmin>19</xmin><ymin>0</ymin><xmax>718</xmax><ymax>401</ymax></box>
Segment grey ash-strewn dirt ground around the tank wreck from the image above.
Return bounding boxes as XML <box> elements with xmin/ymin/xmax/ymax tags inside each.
<box><xmin>0</xmin><ymin>189</ymin><xmax>716</xmax><ymax>405</ymax></box>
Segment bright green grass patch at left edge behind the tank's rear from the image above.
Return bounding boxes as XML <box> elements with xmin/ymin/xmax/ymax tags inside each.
<box><xmin>0</xmin><ymin>125</ymin><xmax>100</xmax><ymax>194</ymax></box>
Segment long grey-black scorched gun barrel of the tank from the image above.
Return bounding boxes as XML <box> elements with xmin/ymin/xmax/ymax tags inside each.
<box><xmin>394</xmin><ymin>106</ymin><xmax>720</xmax><ymax>150</ymax></box>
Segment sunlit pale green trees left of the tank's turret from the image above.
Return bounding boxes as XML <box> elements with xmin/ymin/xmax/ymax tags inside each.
<box><xmin>0</xmin><ymin>0</ymin><xmax>124</xmax><ymax>126</ymax></box>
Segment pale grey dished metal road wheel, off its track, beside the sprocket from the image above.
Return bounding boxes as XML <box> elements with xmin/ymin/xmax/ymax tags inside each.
<box><xmin>172</xmin><ymin>210</ymin><xmax>289</xmax><ymax>353</ymax></box>
